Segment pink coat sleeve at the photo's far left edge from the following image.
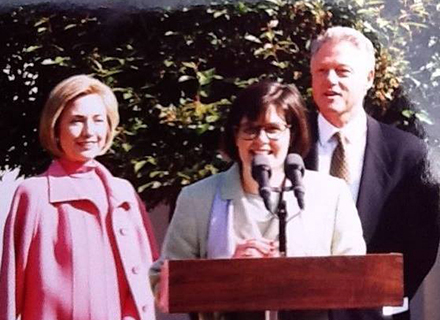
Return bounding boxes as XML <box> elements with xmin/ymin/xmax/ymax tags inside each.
<box><xmin>0</xmin><ymin>182</ymin><xmax>40</xmax><ymax>320</ymax></box>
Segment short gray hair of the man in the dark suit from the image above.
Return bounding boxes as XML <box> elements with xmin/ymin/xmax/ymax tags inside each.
<box><xmin>311</xmin><ymin>26</ymin><xmax>375</xmax><ymax>71</ymax></box>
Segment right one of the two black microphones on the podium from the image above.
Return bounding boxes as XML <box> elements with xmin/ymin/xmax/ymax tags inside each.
<box><xmin>284</xmin><ymin>153</ymin><xmax>305</xmax><ymax>210</ymax></box>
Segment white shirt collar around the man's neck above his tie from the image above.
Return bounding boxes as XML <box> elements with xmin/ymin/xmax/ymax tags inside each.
<box><xmin>318</xmin><ymin>108</ymin><xmax>367</xmax><ymax>146</ymax></box>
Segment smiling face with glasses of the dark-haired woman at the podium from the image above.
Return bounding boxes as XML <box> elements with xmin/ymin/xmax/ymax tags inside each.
<box><xmin>235</xmin><ymin>106</ymin><xmax>290</xmax><ymax>171</ymax></box>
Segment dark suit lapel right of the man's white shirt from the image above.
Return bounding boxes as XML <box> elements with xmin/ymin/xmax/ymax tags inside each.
<box><xmin>356</xmin><ymin>117</ymin><xmax>391</xmax><ymax>244</ymax></box>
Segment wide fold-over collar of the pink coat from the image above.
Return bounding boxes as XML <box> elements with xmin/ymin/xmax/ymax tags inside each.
<box><xmin>46</xmin><ymin>160</ymin><xmax>136</xmax><ymax>207</ymax></box>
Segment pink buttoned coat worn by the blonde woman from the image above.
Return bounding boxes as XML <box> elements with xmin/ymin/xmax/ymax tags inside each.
<box><xmin>0</xmin><ymin>161</ymin><xmax>157</xmax><ymax>320</ymax></box>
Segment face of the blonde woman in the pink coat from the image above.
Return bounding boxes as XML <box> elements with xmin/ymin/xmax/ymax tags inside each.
<box><xmin>58</xmin><ymin>94</ymin><xmax>108</xmax><ymax>162</ymax></box>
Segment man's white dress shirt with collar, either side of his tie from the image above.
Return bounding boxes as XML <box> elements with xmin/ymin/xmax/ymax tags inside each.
<box><xmin>318</xmin><ymin>109</ymin><xmax>367</xmax><ymax>202</ymax></box>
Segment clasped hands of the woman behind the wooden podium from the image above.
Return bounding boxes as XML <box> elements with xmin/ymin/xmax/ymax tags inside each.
<box><xmin>232</xmin><ymin>238</ymin><xmax>279</xmax><ymax>258</ymax></box>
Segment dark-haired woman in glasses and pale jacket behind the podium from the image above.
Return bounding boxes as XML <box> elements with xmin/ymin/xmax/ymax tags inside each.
<box><xmin>150</xmin><ymin>81</ymin><xmax>366</xmax><ymax>320</ymax></box>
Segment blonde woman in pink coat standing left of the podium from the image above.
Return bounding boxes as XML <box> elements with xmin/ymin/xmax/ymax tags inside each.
<box><xmin>0</xmin><ymin>75</ymin><xmax>157</xmax><ymax>320</ymax></box>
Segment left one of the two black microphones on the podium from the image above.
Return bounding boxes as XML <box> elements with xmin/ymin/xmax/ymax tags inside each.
<box><xmin>251</xmin><ymin>154</ymin><xmax>272</xmax><ymax>212</ymax></box>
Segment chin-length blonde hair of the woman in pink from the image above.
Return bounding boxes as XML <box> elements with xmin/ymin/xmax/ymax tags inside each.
<box><xmin>39</xmin><ymin>74</ymin><xmax>119</xmax><ymax>158</ymax></box>
